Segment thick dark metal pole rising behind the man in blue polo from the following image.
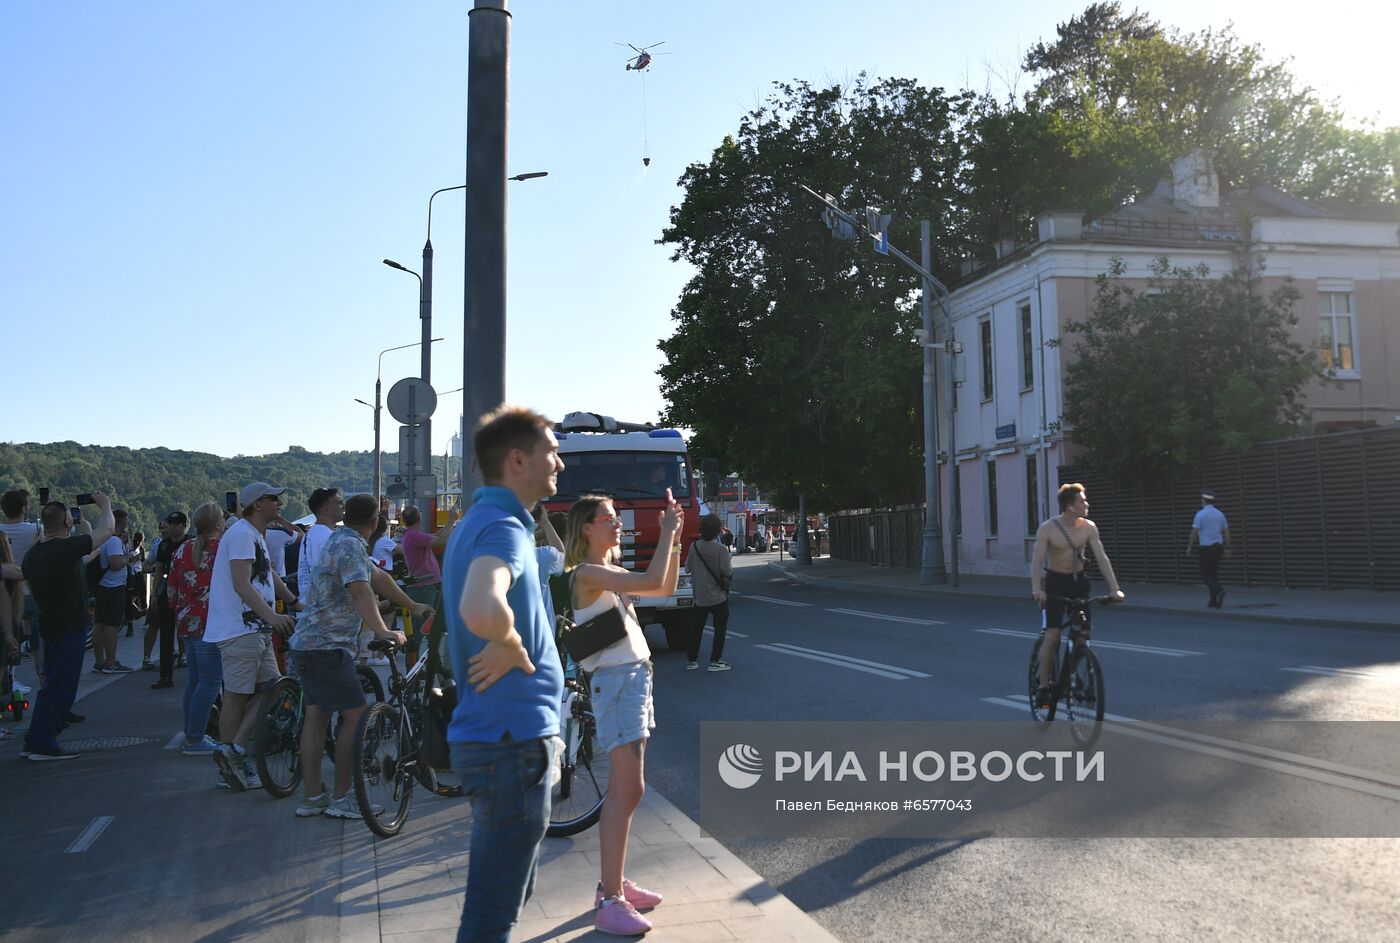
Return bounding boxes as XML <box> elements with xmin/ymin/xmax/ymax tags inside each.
<box><xmin>462</xmin><ymin>0</ymin><xmax>511</xmax><ymax>508</ymax></box>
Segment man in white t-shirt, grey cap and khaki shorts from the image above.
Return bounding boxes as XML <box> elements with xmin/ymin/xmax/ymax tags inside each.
<box><xmin>204</xmin><ymin>481</ymin><xmax>295</xmax><ymax>792</ymax></box>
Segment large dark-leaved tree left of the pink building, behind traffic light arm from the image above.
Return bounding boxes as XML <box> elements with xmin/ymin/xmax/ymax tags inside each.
<box><xmin>658</xmin><ymin>76</ymin><xmax>969</xmax><ymax>508</ymax></box>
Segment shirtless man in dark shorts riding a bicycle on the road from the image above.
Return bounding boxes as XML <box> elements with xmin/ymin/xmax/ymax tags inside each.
<box><xmin>1030</xmin><ymin>484</ymin><xmax>1124</xmax><ymax>705</ymax></box>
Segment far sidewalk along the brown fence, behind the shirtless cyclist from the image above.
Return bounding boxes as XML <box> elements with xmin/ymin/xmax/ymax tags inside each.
<box><xmin>769</xmin><ymin>557</ymin><xmax>1400</xmax><ymax>630</ymax></box>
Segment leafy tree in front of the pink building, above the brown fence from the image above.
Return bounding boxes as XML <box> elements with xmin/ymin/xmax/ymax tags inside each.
<box><xmin>1051</xmin><ymin>253</ymin><xmax>1323</xmax><ymax>484</ymax></box>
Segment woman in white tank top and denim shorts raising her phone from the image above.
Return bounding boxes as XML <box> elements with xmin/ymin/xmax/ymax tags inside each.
<box><xmin>564</xmin><ymin>488</ymin><xmax>682</xmax><ymax>933</ymax></box>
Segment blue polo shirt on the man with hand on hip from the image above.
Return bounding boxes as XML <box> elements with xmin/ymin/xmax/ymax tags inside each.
<box><xmin>442</xmin><ymin>485</ymin><xmax>564</xmax><ymax>743</ymax></box>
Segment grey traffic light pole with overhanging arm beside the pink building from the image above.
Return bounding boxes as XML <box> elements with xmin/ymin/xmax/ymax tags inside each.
<box><xmin>799</xmin><ymin>185</ymin><xmax>959</xmax><ymax>586</ymax></box>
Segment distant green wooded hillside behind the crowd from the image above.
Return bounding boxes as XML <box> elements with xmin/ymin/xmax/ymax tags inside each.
<box><xmin>0</xmin><ymin>442</ymin><xmax>459</xmax><ymax>537</ymax></box>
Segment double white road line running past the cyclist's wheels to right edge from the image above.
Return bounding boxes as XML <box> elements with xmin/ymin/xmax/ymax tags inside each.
<box><xmin>981</xmin><ymin>694</ymin><xmax>1400</xmax><ymax>800</ymax></box>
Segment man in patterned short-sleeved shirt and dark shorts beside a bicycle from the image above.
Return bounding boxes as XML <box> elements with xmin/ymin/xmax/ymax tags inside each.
<box><xmin>291</xmin><ymin>494</ymin><xmax>405</xmax><ymax>818</ymax></box>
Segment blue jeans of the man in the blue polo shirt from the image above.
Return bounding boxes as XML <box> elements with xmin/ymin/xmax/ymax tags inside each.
<box><xmin>451</xmin><ymin>739</ymin><xmax>554</xmax><ymax>943</ymax></box>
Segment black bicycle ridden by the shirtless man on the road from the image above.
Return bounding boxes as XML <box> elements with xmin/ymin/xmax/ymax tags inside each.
<box><xmin>1029</xmin><ymin>596</ymin><xmax>1117</xmax><ymax>750</ymax></box>
